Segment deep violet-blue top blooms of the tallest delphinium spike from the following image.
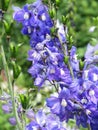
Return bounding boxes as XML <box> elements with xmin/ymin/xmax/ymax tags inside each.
<box><xmin>13</xmin><ymin>0</ymin><xmax>53</xmax><ymax>47</ymax></box>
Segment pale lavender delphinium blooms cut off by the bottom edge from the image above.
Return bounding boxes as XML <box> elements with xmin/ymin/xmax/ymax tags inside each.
<box><xmin>26</xmin><ymin>110</ymin><xmax>65</xmax><ymax>130</ymax></box>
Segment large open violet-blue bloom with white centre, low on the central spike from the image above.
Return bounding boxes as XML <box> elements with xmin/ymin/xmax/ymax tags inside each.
<box><xmin>46</xmin><ymin>88</ymin><xmax>73</xmax><ymax>121</ymax></box>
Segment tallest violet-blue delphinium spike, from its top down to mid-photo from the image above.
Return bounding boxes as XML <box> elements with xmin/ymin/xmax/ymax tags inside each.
<box><xmin>14</xmin><ymin>0</ymin><xmax>71</xmax><ymax>86</ymax></box>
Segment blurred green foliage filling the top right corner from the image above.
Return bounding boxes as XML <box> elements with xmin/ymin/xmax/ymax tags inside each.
<box><xmin>58</xmin><ymin>0</ymin><xmax>98</xmax><ymax>47</ymax></box>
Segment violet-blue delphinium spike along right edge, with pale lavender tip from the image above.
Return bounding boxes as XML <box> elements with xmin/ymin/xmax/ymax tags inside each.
<box><xmin>72</xmin><ymin>45</ymin><xmax>98</xmax><ymax>127</ymax></box>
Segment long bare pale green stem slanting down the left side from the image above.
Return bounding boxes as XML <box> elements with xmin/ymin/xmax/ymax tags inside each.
<box><xmin>0</xmin><ymin>45</ymin><xmax>22</xmax><ymax>130</ymax></box>
